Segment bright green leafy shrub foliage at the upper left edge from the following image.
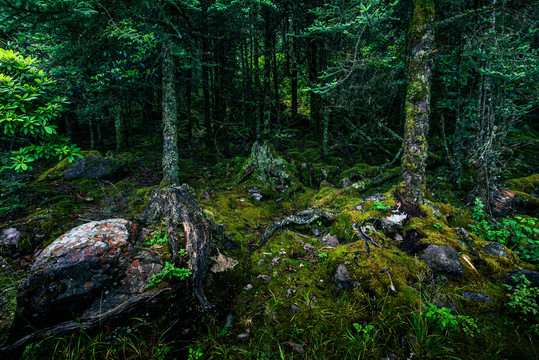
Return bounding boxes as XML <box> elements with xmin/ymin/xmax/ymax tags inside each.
<box><xmin>0</xmin><ymin>48</ymin><xmax>82</xmax><ymax>172</ymax></box>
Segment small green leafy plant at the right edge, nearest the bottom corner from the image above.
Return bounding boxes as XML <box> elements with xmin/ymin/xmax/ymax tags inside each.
<box><xmin>504</xmin><ymin>275</ymin><xmax>539</xmax><ymax>320</ymax></box>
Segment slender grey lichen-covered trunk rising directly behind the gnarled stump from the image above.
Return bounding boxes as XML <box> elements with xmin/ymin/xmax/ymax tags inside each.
<box><xmin>161</xmin><ymin>41</ymin><xmax>180</xmax><ymax>186</ymax></box>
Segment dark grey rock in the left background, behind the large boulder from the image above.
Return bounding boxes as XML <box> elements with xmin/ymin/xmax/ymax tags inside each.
<box><xmin>63</xmin><ymin>155</ymin><xmax>129</xmax><ymax>180</ymax></box>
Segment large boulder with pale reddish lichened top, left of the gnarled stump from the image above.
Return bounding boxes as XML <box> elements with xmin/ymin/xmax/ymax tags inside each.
<box><xmin>11</xmin><ymin>219</ymin><xmax>162</xmax><ymax>338</ymax></box>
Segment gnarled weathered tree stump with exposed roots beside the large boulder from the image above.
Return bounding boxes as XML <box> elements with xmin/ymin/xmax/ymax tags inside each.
<box><xmin>140</xmin><ymin>184</ymin><xmax>216</xmax><ymax>311</ymax></box>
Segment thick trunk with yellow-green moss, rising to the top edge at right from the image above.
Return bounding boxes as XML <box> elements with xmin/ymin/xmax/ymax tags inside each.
<box><xmin>401</xmin><ymin>0</ymin><xmax>434</xmax><ymax>205</ymax></box>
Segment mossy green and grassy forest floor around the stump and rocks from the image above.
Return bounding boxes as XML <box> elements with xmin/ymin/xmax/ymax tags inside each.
<box><xmin>0</xmin><ymin>133</ymin><xmax>539</xmax><ymax>359</ymax></box>
